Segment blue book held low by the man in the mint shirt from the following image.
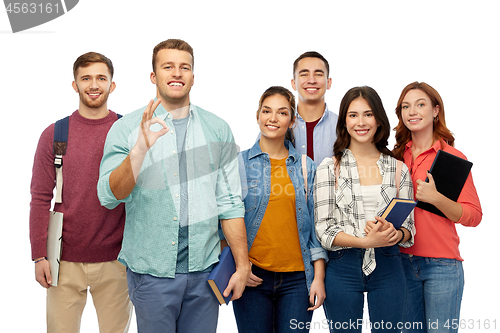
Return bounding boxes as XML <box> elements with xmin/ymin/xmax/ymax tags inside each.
<box><xmin>207</xmin><ymin>246</ymin><xmax>236</xmax><ymax>305</ymax></box>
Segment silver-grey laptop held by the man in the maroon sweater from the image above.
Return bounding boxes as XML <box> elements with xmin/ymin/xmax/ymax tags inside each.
<box><xmin>47</xmin><ymin>211</ymin><xmax>63</xmax><ymax>287</ymax></box>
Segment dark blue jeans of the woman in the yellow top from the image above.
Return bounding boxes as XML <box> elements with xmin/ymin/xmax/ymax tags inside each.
<box><xmin>233</xmin><ymin>265</ymin><xmax>312</xmax><ymax>333</ymax></box>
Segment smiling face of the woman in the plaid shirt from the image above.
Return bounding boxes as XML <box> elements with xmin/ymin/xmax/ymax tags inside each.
<box><xmin>345</xmin><ymin>97</ymin><xmax>378</xmax><ymax>145</ymax></box>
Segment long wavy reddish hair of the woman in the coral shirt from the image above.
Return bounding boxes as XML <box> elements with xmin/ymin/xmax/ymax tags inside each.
<box><xmin>392</xmin><ymin>81</ymin><xmax>455</xmax><ymax>160</ymax></box>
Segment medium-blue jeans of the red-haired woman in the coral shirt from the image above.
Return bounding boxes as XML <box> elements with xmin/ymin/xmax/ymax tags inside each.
<box><xmin>402</xmin><ymin>254</ymin><xmax>464</xmax><ymax>333</ymax></box>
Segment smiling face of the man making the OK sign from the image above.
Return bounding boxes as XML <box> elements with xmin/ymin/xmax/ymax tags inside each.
<box><xmin>151</xmin><ymin>49</ymin><xmax>194</xmax><ymax>111</ymax></box>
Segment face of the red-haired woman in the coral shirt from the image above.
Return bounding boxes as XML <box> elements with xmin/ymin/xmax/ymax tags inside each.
<box><xmin>401</xmin><ymin>89</ymin><xmax>439</xmax><ymax>133</ymax></box>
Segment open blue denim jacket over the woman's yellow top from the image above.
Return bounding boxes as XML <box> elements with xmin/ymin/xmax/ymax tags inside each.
<box><xmin>238</xmin><ymin>140</ymin><xmax>328</xmax><ymax>290</ymax></box>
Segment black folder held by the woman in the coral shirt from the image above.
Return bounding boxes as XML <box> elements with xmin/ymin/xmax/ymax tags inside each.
<box><xmin>417</xmin><ymin>150</ymin><xmax>472</xmax><ymax>217</ymax></box>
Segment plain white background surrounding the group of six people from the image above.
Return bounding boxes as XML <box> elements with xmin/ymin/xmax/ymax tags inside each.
<box><xmin>0</xmin><ymin>0</ymin><xmax>500</xmax><ymax>332</ymax></box>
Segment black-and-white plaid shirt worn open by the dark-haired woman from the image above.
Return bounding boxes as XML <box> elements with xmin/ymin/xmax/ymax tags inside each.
<box><xmin>314</xmin><ymin>149</ymin><xmax>415</xmax><ymax>275</ymax></box>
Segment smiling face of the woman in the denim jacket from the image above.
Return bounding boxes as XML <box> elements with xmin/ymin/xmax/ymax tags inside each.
<box><xmin>257</xmin><ymin>94</ymin><xmax>293</xmax><ymax>141</ymax></box>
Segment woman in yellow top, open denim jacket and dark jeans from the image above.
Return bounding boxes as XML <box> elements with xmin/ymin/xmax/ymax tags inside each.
<box><xmin>233</xmin><ymin>87</ymin><xmax>327</xmax><ymax>333</ymax></box>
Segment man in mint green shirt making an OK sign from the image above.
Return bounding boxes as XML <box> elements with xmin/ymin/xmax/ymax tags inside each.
<box><xmin>97</xmin><ymin>39</ymin><xmax>250</xmax><ymax>333</ymax></box>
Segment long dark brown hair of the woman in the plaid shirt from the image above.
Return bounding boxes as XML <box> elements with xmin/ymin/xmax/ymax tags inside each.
<box><xmin>333</xmin><ymin>86</ymin><xmax>392</xmax><ymax>162</ymax></box>
